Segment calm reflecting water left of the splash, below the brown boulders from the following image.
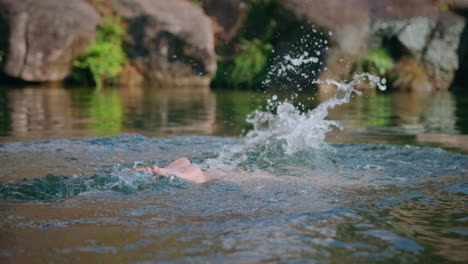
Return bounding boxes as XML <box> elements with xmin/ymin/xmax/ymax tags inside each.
<box><xmin>0</xmin><ymin>87</ymin><xmax>263</xmax><ymax>142</ymax></box>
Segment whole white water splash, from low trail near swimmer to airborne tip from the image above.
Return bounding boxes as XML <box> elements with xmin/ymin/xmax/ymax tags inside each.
<box><xmin>208</xmin><ymin>73</ymin><xmax>386</xmax><ymax>169</ymax></box>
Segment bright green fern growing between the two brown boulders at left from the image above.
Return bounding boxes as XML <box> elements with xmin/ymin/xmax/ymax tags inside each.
<box><xmin>72</xmin><ymin>16</ymin><xmax>127</xmax><ymax>87</ymax></box>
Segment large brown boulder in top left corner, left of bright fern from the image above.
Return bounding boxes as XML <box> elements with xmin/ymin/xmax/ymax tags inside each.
<box><xmin>0</xmin><ymin>0</ymin><xmax>99</xmax><ymax>82</ymax></box>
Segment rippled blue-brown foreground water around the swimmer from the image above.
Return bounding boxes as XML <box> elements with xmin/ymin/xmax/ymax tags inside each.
<box><xmin>0</xmin><ymin>135</ymin><xmax>468</xmax><ymax>263</ymax></box>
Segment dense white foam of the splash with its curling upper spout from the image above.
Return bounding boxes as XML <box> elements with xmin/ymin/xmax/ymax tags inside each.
<box><xmin>246</xmin><ymin>73</ymin><xmax>385</xmax><ymax>154</ymax></box>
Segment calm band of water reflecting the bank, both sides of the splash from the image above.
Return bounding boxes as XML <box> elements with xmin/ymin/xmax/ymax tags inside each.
<box><xmin>0</xmin><ymin>87</ymin><xmax>468</xmax><ymax>153</ymax></box>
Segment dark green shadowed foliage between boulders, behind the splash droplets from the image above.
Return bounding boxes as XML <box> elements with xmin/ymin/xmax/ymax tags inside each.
<box><xmin>213</xmin><ymin>0</ymin><xmax>308</xmax><ymax>87</ymax></box>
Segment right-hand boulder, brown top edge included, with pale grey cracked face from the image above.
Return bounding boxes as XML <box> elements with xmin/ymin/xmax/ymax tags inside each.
<box><xmin>369</xmin><ymin>0</ymin><xmax>466</xmax><ymax>90</ymax></box>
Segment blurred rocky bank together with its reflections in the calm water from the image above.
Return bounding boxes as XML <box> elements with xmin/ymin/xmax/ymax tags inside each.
<box><xmin>0</xmin><ymin>0</ymin><xmax>468</xmax><ymax>153</ymax></box>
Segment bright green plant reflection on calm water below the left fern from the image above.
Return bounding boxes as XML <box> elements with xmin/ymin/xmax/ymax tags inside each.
<box><xmin>89</xmin><ymin>89</ymin><xmax>124</xmax><ymax>132</ymax></box>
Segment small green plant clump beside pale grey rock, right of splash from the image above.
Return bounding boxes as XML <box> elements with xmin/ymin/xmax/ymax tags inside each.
<box><xmin>356</xmin><ymin>47</ymin><xmax>394</xmax><ymax>77</ymax></box>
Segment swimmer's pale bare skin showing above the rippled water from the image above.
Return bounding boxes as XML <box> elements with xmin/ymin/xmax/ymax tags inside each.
<box><xmin>137</xmin><ymin>158</ymin><xmax>214</xmax><ymax>184</ymax></box>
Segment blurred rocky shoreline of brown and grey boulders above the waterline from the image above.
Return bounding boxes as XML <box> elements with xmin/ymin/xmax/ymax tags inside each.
<box><xmin>0</xmin><ymin>0</ymin><xmax>468</xmax><ymax>90</ymax></box>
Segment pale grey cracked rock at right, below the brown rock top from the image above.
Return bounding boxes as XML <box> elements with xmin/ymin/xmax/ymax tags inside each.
<box><xmin>369</xmin><ymin>15</ymin><xmax>465</xmax><ymax>90</ymax></box>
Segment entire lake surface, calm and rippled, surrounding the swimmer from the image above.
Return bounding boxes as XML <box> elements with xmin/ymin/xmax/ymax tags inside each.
<box><xmin>0</xmin><ymin>82</ymin><xmax>468</xmax><ymax>263</ymax></box>
